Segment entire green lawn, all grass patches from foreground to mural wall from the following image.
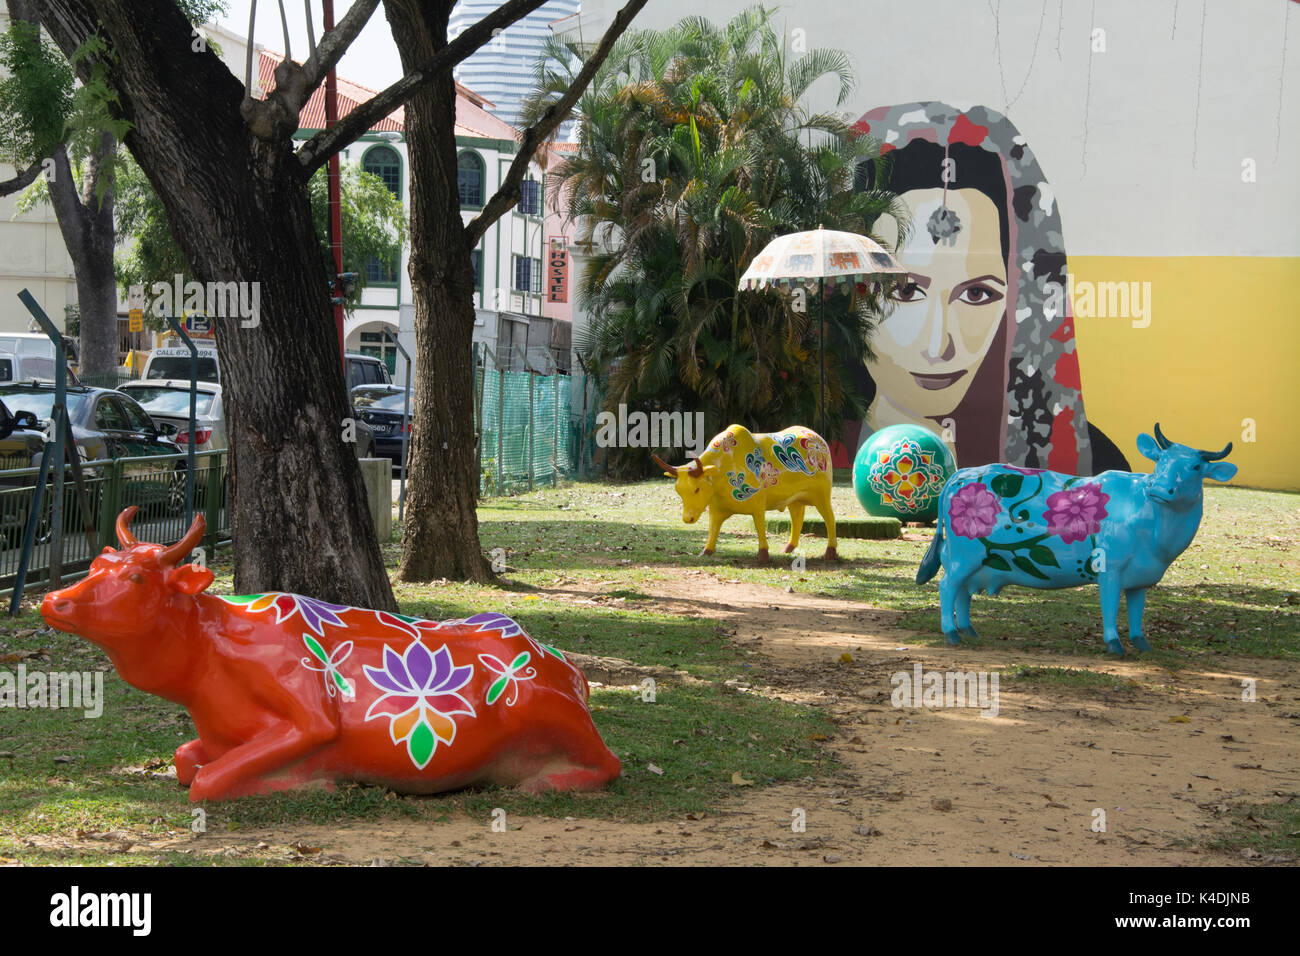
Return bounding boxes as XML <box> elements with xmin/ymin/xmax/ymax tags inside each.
<box><xmin>0</xmin><ymin>480</ymin><xmax>1300</xmax><ymax>864</ymax></box>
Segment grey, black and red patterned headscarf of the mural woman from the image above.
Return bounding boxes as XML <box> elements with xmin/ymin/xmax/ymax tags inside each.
<box><xmin>855</xmin><ymin>103</ymin><xmax>1092</xmax><ymax>475</ymax></box>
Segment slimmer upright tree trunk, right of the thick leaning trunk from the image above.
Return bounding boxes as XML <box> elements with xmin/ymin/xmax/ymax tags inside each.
<box><xmin>384</xmin><ymin>0</ymin><xmax>493</xmax><ymax>581</ymax></box>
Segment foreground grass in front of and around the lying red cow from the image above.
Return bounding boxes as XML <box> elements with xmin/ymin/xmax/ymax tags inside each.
<box><xmin>0</xmin><ymin>684</ymin><xmax>836</xmax><ymax>862</ymax></box>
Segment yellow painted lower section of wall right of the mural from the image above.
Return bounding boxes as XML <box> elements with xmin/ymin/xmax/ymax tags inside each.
<box><xmin>1069</xmin><ymin>256</ymin><xmax>1300</xmax><ymax>490</ymax></box>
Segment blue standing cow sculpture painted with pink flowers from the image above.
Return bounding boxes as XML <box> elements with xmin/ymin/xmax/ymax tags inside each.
<box><xmin>917</xmin><ymin>423</ymin><xmax>1236</xmax><ymax>654</ymax></box>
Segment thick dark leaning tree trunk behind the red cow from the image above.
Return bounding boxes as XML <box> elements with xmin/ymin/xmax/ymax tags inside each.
<box><xmin>42</xmin><ymin>0</ymin><xmax>395</xmax><ymax>610</ymax></box>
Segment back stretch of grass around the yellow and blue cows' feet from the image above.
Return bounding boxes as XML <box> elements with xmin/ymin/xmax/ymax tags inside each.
<box><xmin>462</xmin><ymin>480</ymin><xmax>1300</xmax><ymax>667</ymax></box>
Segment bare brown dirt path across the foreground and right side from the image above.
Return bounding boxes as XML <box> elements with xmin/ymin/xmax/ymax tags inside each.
<box><xmin>109</xmin><ymin>571</ymin><xmax>1300</xmax><ymax>865</ymax></box>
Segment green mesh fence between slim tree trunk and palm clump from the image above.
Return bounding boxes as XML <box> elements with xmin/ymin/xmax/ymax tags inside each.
<box><xmin>475</xmin><ymin>365</ymin><xmax>576</xmax><ymax>496</ymax></box>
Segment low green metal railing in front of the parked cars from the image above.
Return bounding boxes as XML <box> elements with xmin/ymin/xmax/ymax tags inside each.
<box><xmin>0</xmin><ymin>451</ymin><xmax>230</xmax><ymax>593</ymax></box>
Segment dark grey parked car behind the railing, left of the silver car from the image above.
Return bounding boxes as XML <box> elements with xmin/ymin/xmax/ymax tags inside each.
<box><xmin>0</xmin><ymin>382</ymin><xmax>186</xmax><ymax>514</ymax></box>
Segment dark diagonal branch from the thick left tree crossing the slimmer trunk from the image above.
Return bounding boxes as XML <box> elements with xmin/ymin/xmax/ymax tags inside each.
<box><xmin>296</xmin><ymin>0</ymin><xmax>546</xmax><ymax>176</ymax></box>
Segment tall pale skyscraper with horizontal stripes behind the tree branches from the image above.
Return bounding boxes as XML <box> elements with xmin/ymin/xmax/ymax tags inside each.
<box><xmin>447</xmin><ymin>0</ymin><xmax>581</xmax><ymax>140</ymax></box>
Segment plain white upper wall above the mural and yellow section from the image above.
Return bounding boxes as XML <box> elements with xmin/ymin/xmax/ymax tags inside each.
<box><xmin>582</xmin><ymin>0</ymin><xmax>1300</xmax><ymax>256</ymax></box>
